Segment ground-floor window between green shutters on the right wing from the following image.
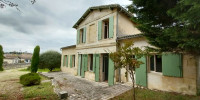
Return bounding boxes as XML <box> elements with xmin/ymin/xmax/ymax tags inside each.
<box><xmin>149</xmin><ymin>55</ymin><xmax>162</xmax><ymax>72</ymax></box>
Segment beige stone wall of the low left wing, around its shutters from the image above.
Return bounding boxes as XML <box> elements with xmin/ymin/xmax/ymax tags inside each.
<box><xmin>61</xmin><ymin>47</ymin><xmax>78</xmax><ymax>75</ymax></box>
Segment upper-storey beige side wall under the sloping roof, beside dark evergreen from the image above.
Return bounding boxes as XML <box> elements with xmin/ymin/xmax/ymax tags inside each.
<box><xmin>117</xmin><ymin>13</ymin><xmax>141</xmax><ymax>37</ymax></box>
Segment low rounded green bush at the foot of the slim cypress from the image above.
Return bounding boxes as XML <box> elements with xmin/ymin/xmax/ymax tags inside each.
<box><xmin>20</xmin><ymin>73</ymin><xmax>41</xmax><ymax>86</ymax></box>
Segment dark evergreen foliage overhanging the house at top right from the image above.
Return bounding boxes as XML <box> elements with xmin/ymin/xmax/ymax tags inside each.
<box><xmin>128</xmin><ymin>0</ymin><xmax>200</xmax><ymax>54</ymax></box>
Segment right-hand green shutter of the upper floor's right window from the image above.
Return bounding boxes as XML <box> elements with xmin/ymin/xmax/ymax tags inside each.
<box><xmin>109</xmin><ymin>16</ymin><xmax>114</xmax><ymax>38</ymax></box>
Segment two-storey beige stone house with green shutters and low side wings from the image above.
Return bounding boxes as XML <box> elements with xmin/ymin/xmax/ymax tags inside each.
<box><xmin>61</xmin><ymin>4</ymin><xmax>198</xmax><ymax>95</ymax></box>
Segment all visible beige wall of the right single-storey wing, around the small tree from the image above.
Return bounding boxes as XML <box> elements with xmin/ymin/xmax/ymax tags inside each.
<box><xmin>120</xmin><ymin>38</ymin><xmax>197</xmax><ymax>95</ymax></box>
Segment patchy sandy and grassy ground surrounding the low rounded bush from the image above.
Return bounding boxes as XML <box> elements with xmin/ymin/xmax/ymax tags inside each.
<box><xmin>0</xmin><ymin>68</ymin><xmax>58</xmax><ymax>100</ymax></box>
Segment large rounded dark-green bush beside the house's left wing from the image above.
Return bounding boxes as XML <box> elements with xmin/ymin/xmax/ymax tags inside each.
<box><xmin>39</xmin><ymin>51</ymin><xmax>61</xmax><ymax>71</ymax></box>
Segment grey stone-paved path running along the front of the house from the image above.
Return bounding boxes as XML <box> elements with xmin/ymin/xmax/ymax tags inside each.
<box><xmin>42</xmin><ymin>72</ymin><xmax>132</xmax><ymax>100</ymax></box>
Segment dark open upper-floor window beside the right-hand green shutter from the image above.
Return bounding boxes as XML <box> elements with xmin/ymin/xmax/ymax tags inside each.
<box><xmin>102</xmin><ymin>19</ymin><xmax>109</xmax><ymax>39</ymax></box>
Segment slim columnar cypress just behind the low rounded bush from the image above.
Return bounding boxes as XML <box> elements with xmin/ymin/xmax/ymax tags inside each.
<box><xmin>31</xmin><ymin>46</ymin><xmax>40</xmax><ymax>73</ymax></box>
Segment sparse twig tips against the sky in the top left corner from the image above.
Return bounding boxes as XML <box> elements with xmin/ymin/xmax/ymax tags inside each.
<box><xmin>0</xmin><ymin>0</ymin><xmax>36</xmax><ymax>11</ymax></box>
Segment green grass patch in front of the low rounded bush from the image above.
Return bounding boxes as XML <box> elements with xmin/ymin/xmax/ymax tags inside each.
<box><xmin>23</xmin><ymin>82</ymin><xmax>58</xmax><ymax>100</ymax></box>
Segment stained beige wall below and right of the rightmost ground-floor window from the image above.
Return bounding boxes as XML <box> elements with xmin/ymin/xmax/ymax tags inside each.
<box><xmin>148</xmin><ymin>55</ymin><xmax>197</xmax><ymax>95</ymax></box>
